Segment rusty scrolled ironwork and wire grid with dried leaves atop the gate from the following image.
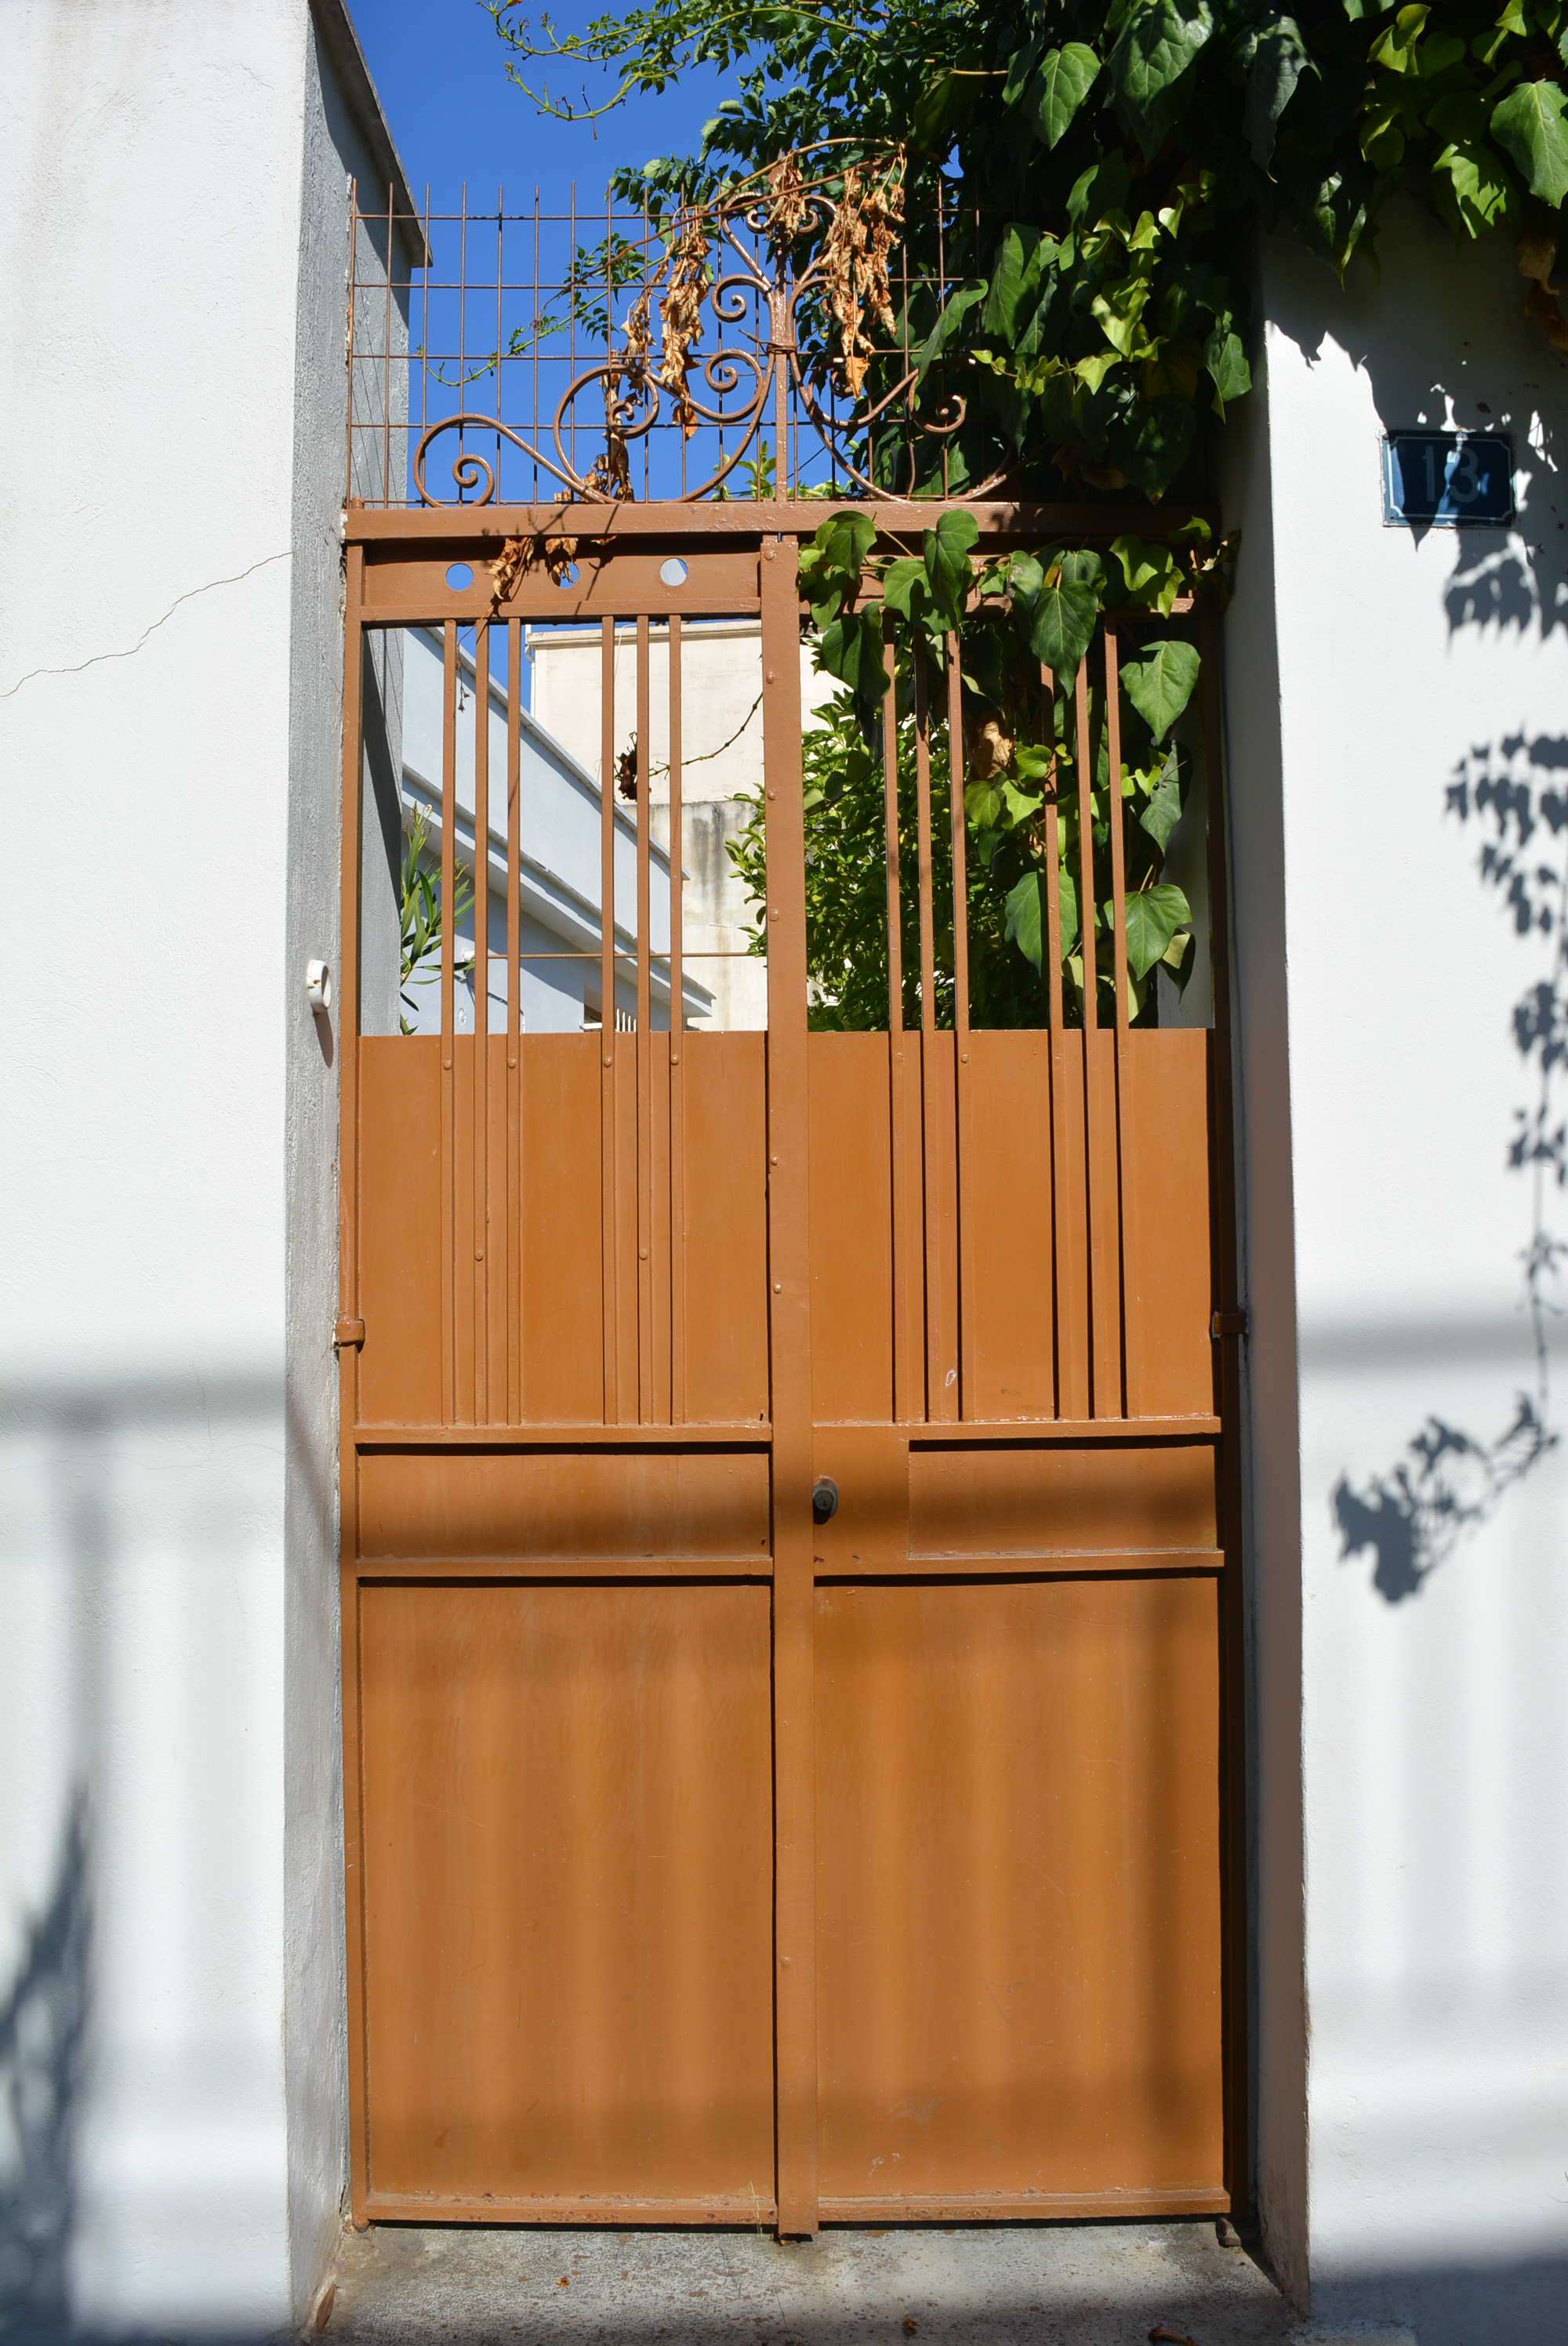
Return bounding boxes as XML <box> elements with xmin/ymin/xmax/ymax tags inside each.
<box><xmin>347</xmin><ymin>152</ymin><xmax>1000</xmax><ymax>509</ymax></box>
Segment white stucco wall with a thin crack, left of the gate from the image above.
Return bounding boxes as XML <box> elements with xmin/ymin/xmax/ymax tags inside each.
<box><xmin>0</xmin><ymin>0</ymin><xmax>410</xmax><ymax>2334</ymax></box>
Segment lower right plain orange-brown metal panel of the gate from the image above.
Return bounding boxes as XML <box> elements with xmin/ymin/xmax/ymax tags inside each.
<box><xmin>817</xmin><ymin>1577</ymin><xmax>1228</xmax><ymax>2219</ymax></box>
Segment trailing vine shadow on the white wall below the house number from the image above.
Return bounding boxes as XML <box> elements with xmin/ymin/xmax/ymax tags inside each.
<box><xmin>1331</xmin><ymin>734</ymin><xmax>1568</xmax><ymax>1605</ymax></box>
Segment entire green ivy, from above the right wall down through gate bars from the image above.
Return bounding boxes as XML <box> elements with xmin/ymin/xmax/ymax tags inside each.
<box><xmin>484</xmin><ymin>0</ymin><xmax>1568</xmax><ymax>1026</ymax></box>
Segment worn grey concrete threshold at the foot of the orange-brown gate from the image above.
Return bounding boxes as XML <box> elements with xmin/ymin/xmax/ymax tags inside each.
<box><xmin>326</xmin><ymin>2221</ymin><xmax>1415</xmax><ymax>2346</ymax></box>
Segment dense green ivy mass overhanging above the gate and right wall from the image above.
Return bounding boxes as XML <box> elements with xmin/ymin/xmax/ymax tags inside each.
<box><xmin>486</xmin><ymin>0</ymin><xmax>1568</xmax><ymax>511</ymax></box>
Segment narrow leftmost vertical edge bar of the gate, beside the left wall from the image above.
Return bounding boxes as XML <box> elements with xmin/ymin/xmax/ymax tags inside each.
<box><xmin>338</xmin><ymin>547</ymin><xmax>371</xmax><ymax>2221</ymax></box>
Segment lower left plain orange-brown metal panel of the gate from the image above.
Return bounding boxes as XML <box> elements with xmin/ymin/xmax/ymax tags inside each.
<box><xmin>359</xmin><ymin>1584</ymin><xmax>772</xmax><ymax>2219</ymax></box>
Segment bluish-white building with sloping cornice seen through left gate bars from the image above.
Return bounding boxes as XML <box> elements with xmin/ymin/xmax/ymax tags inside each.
<box><xmin>401</xmin><ymin>629</ymin><xmax>713</xmax><ymax>1034</ymax></box>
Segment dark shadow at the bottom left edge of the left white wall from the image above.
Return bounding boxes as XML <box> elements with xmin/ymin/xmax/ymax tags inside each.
<box><xmin>0</xmin><ymin>1788</ymin><xmax>92</xmax><ymax>2337</ymax></box>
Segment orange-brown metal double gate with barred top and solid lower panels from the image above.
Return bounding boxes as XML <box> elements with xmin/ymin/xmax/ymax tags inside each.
<box><xmin>338</xmin><ymin>509</ymin><xmax>1244</xmax><ymax>2233</ymax></box>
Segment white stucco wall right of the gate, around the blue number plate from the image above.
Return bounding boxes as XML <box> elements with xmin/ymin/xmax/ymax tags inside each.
<box><xmin>1228</xmin><ymin>209</ymin><xmax>1568</xmax><ymax>2346</ymax></box>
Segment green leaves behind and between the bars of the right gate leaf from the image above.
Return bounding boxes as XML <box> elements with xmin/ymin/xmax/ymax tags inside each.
<box><xmin>730</xmin><ymin>509</ymin><xmax>1214</xmax><ymax>1027</ymax></box>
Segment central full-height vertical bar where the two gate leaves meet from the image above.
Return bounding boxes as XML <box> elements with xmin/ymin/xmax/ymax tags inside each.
<box><xmin>760</xmin><ymin>537</ymin><xmax>817</xmax><ymax>2233</ymax></box>
